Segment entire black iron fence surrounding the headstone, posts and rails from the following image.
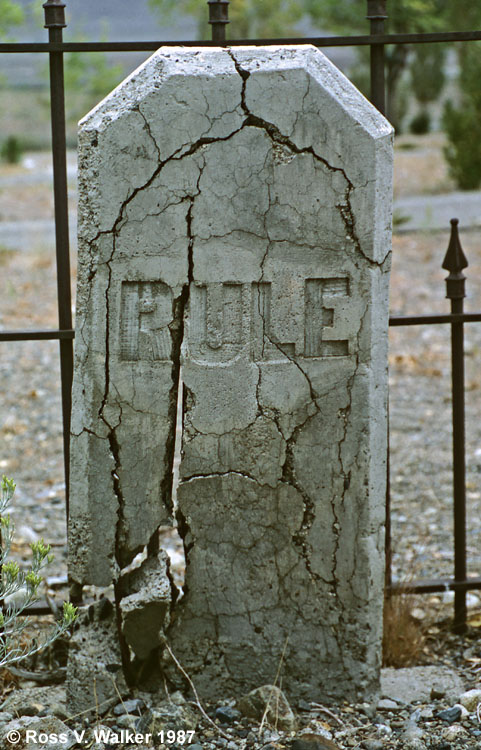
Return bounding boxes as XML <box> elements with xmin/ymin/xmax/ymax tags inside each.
<box><xmin>0</xmin><ymin>0</ymin><xmax>481</xmax><ymax>632</ymax></box>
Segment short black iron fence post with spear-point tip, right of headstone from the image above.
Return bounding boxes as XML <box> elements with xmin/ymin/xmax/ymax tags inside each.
<box><xmin>442</xmin><ymin>219</ymin><xmax>468</xmax><ymax>633</ymax></box>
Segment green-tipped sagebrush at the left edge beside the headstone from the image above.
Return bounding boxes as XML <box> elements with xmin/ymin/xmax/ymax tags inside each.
<box><xmin>0</xmin><ymin>474</ymin><xmax>77</xmax><ymax>667</ymax></box>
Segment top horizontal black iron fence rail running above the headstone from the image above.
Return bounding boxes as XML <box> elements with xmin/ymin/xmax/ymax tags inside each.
<box><xmin>0</xmin><ymin>31</ymin><xmax>481</xmax><ymax>53</ymax></box>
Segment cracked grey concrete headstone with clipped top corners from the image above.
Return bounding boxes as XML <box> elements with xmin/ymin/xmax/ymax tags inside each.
<box><xmin>70</xmin><ymin>45</ymin><xmax>392</xmax><ymax>700</ymax></box>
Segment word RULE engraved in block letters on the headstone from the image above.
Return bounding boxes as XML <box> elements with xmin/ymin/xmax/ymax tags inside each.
<box><xmin>120</xmin><ymin>277</ymin><xmax>352</xmax><ymax>363</ymax></box>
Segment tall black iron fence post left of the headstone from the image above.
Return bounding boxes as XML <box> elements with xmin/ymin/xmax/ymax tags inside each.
<box><xmin>42</xmin><ymin>0</ymin><xmax>73</xmax><ymax>519</ymax></box>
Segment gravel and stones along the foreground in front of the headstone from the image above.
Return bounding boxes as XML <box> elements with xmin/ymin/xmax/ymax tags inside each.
<box><xmin>0</xmin><ymin>652</ymin><xmax>481</xmax><ymax>750</ymax></box>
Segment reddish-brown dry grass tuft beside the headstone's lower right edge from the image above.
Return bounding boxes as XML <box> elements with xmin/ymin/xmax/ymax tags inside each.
<box><xmin>382</xmin><ymin>592</ymin><xmax>426</xmax><ymax>667</ymax></box>
